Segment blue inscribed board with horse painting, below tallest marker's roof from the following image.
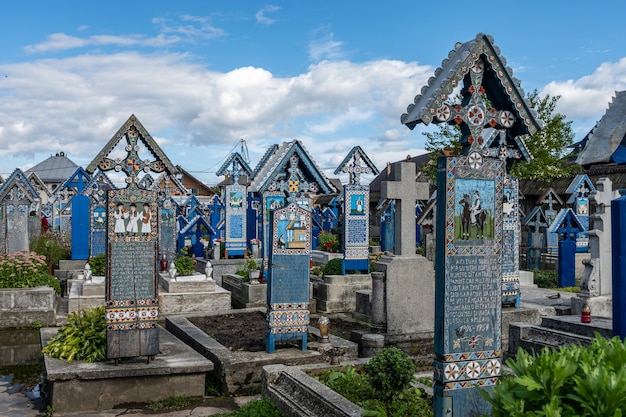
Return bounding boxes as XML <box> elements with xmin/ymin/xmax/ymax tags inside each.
<box><xmin>434</xmin><ymin>152</ymin><xmax>504</xmax><ymax>416</ymax></box>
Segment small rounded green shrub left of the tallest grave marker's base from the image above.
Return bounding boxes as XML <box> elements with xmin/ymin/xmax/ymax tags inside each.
<box><xmin>364</xmin><ymin>347</ymin><xmax>416</xmax><ymax>400</ymax></box>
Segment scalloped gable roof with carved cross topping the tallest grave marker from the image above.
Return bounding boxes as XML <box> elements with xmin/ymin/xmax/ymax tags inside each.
<box><xmin>400</xmin><ymin>33</ymin><xmax>541</xmax><ymax>160</ymax></box>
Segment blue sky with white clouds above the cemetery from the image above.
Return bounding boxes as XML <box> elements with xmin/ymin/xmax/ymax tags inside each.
<box><xmin>0</xmin><ymin>0</ymin><xmax>626</xmax><ymax>184</ymax></box>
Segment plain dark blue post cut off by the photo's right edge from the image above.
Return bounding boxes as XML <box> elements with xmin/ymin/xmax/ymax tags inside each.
<box><xmin>611</xmin><ymin>192</ymin><xmax>626</xmax><ymax>340</ymax></box>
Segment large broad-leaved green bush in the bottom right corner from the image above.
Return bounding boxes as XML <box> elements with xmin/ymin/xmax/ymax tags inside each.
<box><xmin>481</xmin><ymin>334</ymin><xmax>626</xmax><ymax>417</ymax></box>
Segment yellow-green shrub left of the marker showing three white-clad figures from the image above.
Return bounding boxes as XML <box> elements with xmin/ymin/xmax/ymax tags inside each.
<box><xmin>42</xmin><ymin>306</ymin><xmax>106</xmax><ymax>363</ymax></box>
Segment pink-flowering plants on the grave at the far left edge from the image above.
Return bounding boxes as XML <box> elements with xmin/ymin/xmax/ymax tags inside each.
<box><xmin>0</xmin><ymin>251</ymin><xmax>61</xmax><ymax>294</ymax></box>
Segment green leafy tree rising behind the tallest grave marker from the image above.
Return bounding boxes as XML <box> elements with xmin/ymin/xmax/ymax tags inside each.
<box><xmin>422</xmin><ymin>90</ymin><xmax>574</xmax><ymax>180</ymax></box>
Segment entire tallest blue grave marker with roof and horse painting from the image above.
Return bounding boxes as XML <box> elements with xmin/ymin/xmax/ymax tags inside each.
<box><xmin>401</xmin><ymin>33</ymin><xmax>541</xmax><ymax>417</ymax></box>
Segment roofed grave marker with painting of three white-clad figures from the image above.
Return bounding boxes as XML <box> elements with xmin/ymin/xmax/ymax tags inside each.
<box><xmin>87</xmin><ymin>115</ymin><xmax>178</xmax><ymax>364</ymax></box>
